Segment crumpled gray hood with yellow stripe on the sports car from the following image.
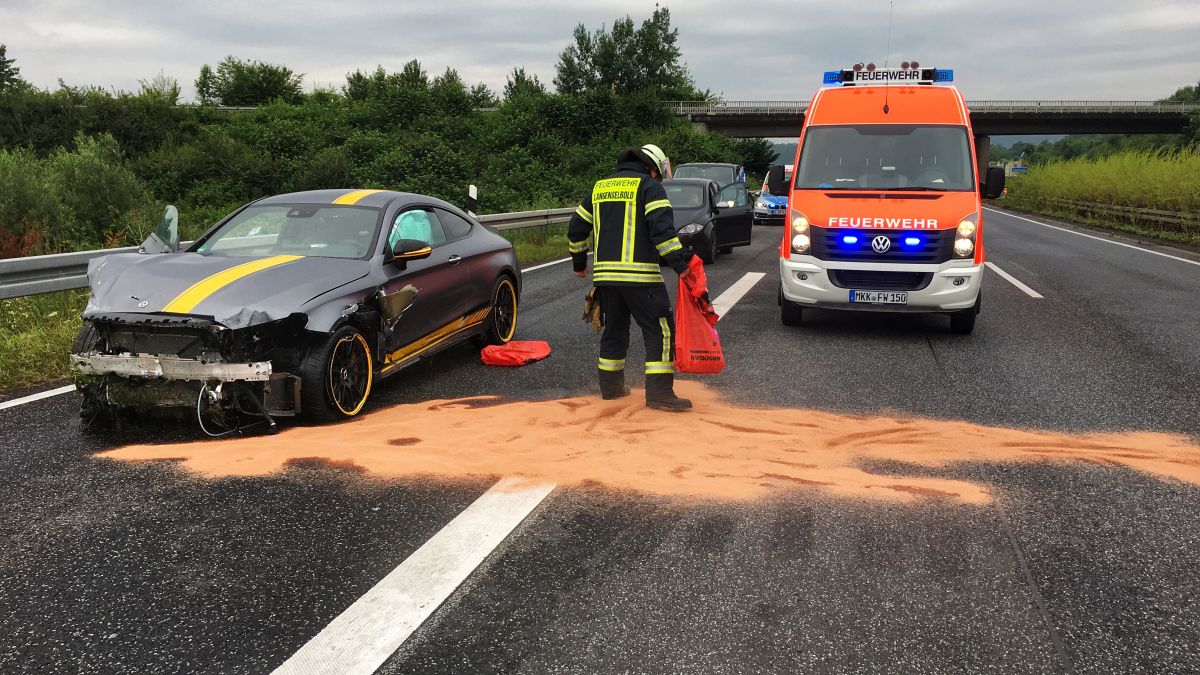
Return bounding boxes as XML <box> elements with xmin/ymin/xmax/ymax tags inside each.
<box><xmin>84</xmin><ymin>253</ymin><xmax>371</xmax><ymax>328</ymax></box>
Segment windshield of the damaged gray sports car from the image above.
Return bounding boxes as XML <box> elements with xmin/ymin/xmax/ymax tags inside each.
<box><xmin>197</xmin><ymin>204</ymin><xmax>379</xmax><ymax>258</ymax></box>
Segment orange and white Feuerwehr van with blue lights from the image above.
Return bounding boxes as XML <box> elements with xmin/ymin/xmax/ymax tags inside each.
<box><xmin>768</xmin><ymin>62</ymin><xmax>1004</xmax><ymax>334</ymax></box>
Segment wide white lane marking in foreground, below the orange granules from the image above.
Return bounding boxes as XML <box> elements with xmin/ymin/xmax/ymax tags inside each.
<box><xmin>275</xmin><ymin>478</ymin><xmax>554</xmax><ymax>675</ymax></box>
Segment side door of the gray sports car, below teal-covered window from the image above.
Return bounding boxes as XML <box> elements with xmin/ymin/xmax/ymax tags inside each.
<box><xmin>383</xmin><ymin>207</ymin><xmax>467</xmax><ymax>362</ymax></box>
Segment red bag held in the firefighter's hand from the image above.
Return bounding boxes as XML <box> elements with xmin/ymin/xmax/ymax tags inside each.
<box><xmin>676</xmin><ymin>257</ymin><xmax>725</xmax><ymax>375</ymax></box>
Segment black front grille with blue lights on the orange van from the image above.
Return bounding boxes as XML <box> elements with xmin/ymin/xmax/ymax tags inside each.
<box><xmin>811</xmin><ymin>227</ymin><xmax>954</xmax><ymax>263</ymax></box>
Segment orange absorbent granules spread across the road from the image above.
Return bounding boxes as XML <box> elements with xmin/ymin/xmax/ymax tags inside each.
<box><xmin>100</xmin><ymin>382</ymin><xmax>1200</xmax><ymax>503</ymax></box>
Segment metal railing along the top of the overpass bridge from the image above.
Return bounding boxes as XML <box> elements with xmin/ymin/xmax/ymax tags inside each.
<box><xmin>666</xmin><ymin>100</ymin><xmax>1200</xmax><ymax>115</ymax></box>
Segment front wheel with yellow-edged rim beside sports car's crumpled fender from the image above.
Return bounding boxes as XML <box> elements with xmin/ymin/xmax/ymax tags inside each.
<box><xmin>300</xmin><ymin>325</ymin><xmax>374</xmax><ymax>422</ymax></box>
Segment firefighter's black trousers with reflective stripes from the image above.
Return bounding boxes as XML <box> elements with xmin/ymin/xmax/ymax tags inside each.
<box><xmin>596</xmin><ymin>283</ymin><xmax>674</xmax><ymax>374</ymax></box>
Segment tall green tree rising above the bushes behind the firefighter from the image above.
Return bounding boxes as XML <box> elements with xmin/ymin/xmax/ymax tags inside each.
<box><xmin>554</xmin><ymin>6</ymin><xmax>703</xmax><ymax>98</ymax></box>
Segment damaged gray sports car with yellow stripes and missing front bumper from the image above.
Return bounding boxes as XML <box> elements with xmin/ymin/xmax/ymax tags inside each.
<box><xmin>72</xmin><ymin>190</ymin><xmax>521</xmax><ymax>435</ymax></box>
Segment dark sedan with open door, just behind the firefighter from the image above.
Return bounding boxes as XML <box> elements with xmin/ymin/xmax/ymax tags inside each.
<box><xmin>662</xmin><ymin>178</ymin><xmax>752</xmax><ymax>264</ymax></box>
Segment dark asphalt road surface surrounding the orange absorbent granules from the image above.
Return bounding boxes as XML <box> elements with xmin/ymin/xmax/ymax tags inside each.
<box><xmin>0</xmin><ymin>210</ymin><xmax>1200</xmax><ymax>674</ymax></box>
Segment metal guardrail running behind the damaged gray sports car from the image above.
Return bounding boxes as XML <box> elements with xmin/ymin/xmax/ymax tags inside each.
<box><xmin>0</xmin><ymin>209</ymin><xmax>575</xmax><ymax>299</ymax></box>
